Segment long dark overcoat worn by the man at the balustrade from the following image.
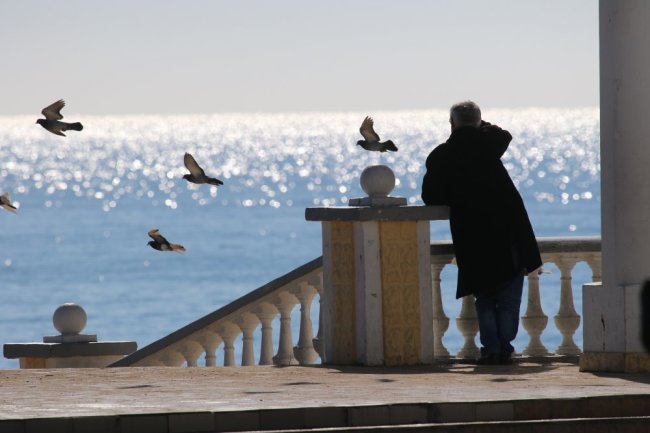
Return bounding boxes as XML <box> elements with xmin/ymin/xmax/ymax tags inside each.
<box><xmin>422</xmin><ymin>122</ymin><xmax>542</xmax><ymax>298</ymax></box>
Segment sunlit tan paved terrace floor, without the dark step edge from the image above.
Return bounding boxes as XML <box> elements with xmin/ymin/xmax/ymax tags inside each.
<box><xmin>0</xmin><ymin>363</ymin><xmax>650</xmax><ymax>420</ymax></box>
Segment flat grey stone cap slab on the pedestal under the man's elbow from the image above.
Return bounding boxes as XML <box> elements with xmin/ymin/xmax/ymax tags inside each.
<box><xmin>305</xmin><ymin>206</ymin><xmax>449</xmax><ymax>221</ymax></box>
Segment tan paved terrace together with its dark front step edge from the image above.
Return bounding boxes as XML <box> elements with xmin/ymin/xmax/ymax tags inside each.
<box><xmin>0</xmin><ymin>364</ymin><xmax>650</xmax><ymax>433</ymax></box>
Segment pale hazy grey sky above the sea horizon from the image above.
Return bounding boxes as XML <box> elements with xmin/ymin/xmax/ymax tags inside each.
<box><xmin>0</xmin><ymin>0</ymin><xmax>599</xmax><ymax>115</ymax></box>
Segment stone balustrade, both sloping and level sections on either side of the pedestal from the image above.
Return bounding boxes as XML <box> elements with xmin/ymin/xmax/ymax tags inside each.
<box><xmin>113</xmin><ymin>237</ymin><xmax>601</xmax><ymax>367</ymax></box>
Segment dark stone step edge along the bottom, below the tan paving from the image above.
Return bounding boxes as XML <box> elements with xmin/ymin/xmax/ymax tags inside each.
<box><xmin>0</xmin><ymin>395</ymin><xmax>650</xmax><ymax>433</ymax></box>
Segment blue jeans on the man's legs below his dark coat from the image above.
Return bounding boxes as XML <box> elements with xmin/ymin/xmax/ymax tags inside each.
<box><xmin>474</xmin><ymin>271</ymin><xmax>524</xmax><ymax>356</ymax></box>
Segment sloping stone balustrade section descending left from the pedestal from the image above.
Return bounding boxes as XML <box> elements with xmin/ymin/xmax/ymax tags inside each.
<box><xmin>111</xmin><ymin>257</ymin><xmax>323</xmax><ymax>367</ymax></box>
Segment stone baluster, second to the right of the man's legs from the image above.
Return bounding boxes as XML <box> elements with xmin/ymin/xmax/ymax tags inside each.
<box><xmin>554</xmin><ymin>256</ymin><xmax>581</xmax><ymax>355</ymax></box>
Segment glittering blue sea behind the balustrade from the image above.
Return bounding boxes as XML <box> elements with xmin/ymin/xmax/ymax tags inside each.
<box><xmin>0</xmin><ymin>108</ymin><xmax>600</xmax><ymax>368</ymax></box>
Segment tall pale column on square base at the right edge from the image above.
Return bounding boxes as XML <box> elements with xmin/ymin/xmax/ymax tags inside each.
<box><xmin>580</xmin><ymin>0</ymin><xmax>650</xmax><ymax>372</ymax></box>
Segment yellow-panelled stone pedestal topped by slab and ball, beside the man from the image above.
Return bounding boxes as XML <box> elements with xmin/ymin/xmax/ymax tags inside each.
<box><xmin>306</xmin><ymin>166</ymin><xmax>449</xmax><ymax>366</ymax></box>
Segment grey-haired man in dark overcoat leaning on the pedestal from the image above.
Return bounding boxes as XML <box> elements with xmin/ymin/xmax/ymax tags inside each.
<box><xmin>422</xmin><ymin>101</ymin><xmax>542</xmax><ymax>364</ymax></box>
